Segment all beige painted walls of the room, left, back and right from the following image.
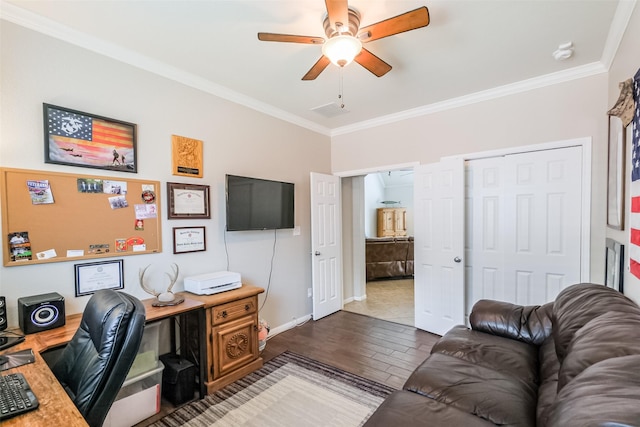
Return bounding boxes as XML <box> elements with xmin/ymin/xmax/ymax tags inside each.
<box><xmin>0</xmin><ymin>2</ymin><xmax>640</xmax><ymax>327</ymax></box>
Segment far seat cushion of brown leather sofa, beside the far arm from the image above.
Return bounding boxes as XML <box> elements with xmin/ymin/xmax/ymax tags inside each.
<box><xmin>431</xmin><ymin>326</ymin><xmax>538</xmax><ymax>386</ymax></box>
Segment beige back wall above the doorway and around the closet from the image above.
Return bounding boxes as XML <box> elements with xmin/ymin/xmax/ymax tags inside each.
<box><xmin>331</xmin><ymin>73</ymin><xmax>607</xmax><ymax>290</ymax></box>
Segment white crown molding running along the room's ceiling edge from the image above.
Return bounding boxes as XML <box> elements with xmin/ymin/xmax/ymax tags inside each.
<box><xmin>0</xmin><ymin>0</ymin><xmax>637</xmax><ymax>137</ymax></box>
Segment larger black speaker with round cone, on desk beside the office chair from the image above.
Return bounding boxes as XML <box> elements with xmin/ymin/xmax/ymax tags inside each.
<box><xmin>18</xmin><ymin>292</ymin><xmax>66</xmax><ymax>334</ymax></box>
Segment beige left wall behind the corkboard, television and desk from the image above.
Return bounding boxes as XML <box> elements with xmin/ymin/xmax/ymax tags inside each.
<box><xmin>0</xmin><ymin>21</ymin><xmax>331</xmax><ymax>326</ymax></box>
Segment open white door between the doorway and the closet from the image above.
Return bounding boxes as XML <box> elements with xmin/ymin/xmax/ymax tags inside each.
<box><xmin>414</xmin><ymin>158</ymin><xmax>465</xmax><ymax>335</ymax></box>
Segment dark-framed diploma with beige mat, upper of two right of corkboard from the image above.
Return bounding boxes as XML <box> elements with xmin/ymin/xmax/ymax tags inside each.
<box><xmin>167</xmin><ymin>182</ymin><xmax>211</xmax><ymax>219</ymax></box>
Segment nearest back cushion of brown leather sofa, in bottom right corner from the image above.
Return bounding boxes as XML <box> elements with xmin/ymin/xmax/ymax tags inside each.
<box><xmin>547</xmin><ymin>355</ymin><xmax>640</xmax><ymax>427</ymax></box>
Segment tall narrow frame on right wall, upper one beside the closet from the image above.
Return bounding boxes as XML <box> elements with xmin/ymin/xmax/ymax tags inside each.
<box><xmin>607</xmin><ymin>116</ymin><xmax>626</xmax><ymax>230</ymax></box>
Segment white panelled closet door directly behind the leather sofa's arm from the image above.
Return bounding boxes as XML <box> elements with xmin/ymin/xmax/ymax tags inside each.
<box><xmin>466</xmin><ymin>147</ymin><xmax>582</xmax><ymax>313</ymax></box>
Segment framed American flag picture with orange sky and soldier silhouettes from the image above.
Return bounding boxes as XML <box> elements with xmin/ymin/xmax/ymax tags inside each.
<box><xmin>42</xmin><ymin>103</ymin><xmax>138</xmax><ymax>173</ymax></box>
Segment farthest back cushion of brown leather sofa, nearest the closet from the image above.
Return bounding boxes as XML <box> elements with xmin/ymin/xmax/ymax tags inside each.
<box><xmin>552</xmin><ymin>283</ymin><xmax>638</xmax><ymax>362</ymax></box>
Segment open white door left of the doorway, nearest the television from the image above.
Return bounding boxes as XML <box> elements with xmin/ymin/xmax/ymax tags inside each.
<box><xmin>311</xmin><ymin>172</ymin><xmax>342</xmax><ymax>320</ymax></box>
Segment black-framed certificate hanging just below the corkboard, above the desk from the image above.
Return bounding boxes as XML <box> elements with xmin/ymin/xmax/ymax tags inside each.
<box><xmin>75</xmin><ymin>259</ymin><xmax>124</xmax><ymax>297</ymax></box>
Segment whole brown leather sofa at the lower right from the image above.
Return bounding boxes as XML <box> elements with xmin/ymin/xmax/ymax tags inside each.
<box><xmin>365</xmin><ymin>284</ymin><xmax>640</xmax><ymax>427</ymax></box>
